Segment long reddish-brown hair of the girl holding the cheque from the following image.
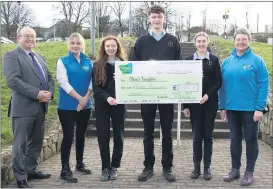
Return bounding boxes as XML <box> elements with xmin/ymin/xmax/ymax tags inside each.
<box><xmin>95</xmin><ymin>35</ymin><xmax>127</xmax><ymax>86</ymax></box>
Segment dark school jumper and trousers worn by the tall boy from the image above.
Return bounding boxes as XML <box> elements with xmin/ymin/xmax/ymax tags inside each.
<box><xmin>132</xmin><ymin>33</ymin><xmax>181</xmax><ymax>170</ymax></box>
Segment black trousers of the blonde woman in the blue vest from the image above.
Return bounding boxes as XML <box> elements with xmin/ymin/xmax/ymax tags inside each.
<box><xmin>58</xmin><ymin>108</ymin><xmax>91</xmax><ymax>164</ymax></box>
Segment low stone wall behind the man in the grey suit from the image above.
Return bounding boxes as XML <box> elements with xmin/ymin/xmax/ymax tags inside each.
<box><xmin>1</xmin><ymin>124</ymin><xmax>63</xmax><ymax>187</ymax></box>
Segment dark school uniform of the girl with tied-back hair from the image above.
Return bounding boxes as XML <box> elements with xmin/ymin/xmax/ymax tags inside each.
<box><xmin>183</xmin><ymin>52</ymin><xmax>222</xmax><ymax>168</ymax></box>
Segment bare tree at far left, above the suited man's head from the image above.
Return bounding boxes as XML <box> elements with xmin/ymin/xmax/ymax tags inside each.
<box><xmin>0</xmin><ymin>1</ymin><xmax>35</xmax><ymax>38</ymax></box>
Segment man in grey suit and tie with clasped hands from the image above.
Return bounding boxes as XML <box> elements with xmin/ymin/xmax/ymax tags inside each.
<box><xmin>4</xmin><ymin>26</ymin><xmax>54</xmax><ymax>188</ymax></box>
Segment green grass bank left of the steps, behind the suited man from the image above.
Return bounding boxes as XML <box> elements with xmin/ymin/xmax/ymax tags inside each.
<box><xmin>1</xmin><ymin>37</ymin><xmax>136</xmax><ymax>148</ymax></box>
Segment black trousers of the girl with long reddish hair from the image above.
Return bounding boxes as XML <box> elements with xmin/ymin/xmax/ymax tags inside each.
<box><xmin>95</xmin><ymin>99</ymin><xmax>125</xmax><ymax>170</ymax></box>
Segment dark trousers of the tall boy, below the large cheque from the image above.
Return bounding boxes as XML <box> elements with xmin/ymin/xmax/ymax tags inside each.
<box><xmin>141</xmin><ymin>104</ymin><xmax>174</xmax><ymax>169</ymax></box>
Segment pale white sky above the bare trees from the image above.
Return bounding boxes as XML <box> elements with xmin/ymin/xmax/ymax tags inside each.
<box><xmin>25</xmin><ymin>2</ymin><xmax>273</xmax><ymax>32</ymax></box>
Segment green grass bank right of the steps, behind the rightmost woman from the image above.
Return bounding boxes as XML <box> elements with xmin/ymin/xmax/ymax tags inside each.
<box><xmin>211</xmin><ymin>39</ymin><xmax>273</xmax><ymax>75</ymax></box>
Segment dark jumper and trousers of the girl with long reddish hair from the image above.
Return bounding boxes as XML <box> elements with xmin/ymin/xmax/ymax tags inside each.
<box><xmin>92</xmin><ymin>63</ymin><xmax>125</xmax><ymax>170</ymax></box>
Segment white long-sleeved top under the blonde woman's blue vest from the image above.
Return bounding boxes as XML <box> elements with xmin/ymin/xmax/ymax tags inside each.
<box><xmin>56</xmin><ymin>59</ymin><xmax>92</xmax><ymax>94</ymax></box>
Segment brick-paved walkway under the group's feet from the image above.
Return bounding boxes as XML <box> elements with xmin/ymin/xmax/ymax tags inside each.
<box><xmin>3</xmin><ymin>138</ymin><xmax>272</xmax><ymax>188</ymax></box>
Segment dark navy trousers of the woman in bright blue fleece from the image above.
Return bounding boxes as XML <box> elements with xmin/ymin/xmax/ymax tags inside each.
<box><xmin>227</xmin><ymin>110</ymin><xmax>259</xmax><ymax>172</ymax></box>
